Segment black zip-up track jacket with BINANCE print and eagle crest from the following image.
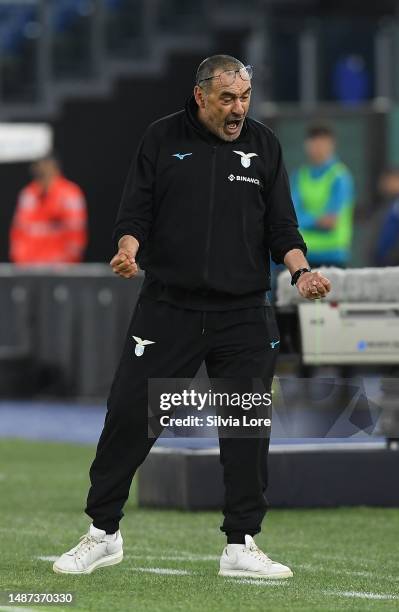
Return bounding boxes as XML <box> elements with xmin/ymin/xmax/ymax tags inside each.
<box><xmin>113</xmin><ymin>97</ymin><xmax>306</xmax><ymax>310</ymax></box>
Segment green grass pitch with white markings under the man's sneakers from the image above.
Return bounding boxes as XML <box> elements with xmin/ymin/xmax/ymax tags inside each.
<box><xmin>0</xmin><ymin>440</ymin><xmax>399</xmax><ymax>612</ymax></box>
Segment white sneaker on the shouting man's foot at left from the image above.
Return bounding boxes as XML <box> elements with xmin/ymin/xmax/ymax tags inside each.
<box><xmin>53</xmin><ymin>525</ymin><xmax>123</xmax><ymax>574</ymax></box>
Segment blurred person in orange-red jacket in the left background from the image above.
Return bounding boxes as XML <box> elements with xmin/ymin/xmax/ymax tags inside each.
<box><xmin>9</xmin><ymin>154</ymin><xmax>87</xmax><ymax>264</ymax></box>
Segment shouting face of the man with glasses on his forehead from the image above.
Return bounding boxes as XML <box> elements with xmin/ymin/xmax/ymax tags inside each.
<box><xmin>194</xmin><ymin>71</ymin><xmax>251</xmax><ymax>141</ymax></box>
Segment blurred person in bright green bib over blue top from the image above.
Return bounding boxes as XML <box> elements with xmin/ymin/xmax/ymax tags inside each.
<box><xmin>291</xmin><ymin>125</ymin><xmax>355</xmax><ymax>267</ymax></box>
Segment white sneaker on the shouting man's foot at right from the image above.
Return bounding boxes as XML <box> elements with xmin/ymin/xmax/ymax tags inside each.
<box><xmin>219</xmin><ymin>535</ymin><xmax>293</xmax><ymax>579</ymax></box>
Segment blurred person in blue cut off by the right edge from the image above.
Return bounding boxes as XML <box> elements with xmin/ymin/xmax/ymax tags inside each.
<box><xmin>373</xmin><ymin>168</ymin><xmax>399</xmax><ymax>266</ymax></box>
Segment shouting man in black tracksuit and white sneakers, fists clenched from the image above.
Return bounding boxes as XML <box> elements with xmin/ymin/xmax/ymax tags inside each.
<box><xmin>54</xmin><ymin>56</ymin><xmax>329</xmax><ymax>578</ymax></box>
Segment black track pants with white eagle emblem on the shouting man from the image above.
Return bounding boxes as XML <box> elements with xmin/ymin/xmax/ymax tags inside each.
<box><xmin>86</xmin><ymin>297</ymin><xmax>278</xmax><ymax>535</ymax></box>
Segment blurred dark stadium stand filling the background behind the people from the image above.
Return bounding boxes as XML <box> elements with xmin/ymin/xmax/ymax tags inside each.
<box><xmin>0</xmin><ymin>0</ymin><xmax>399</xmax><ymax>265</ymax></box>
